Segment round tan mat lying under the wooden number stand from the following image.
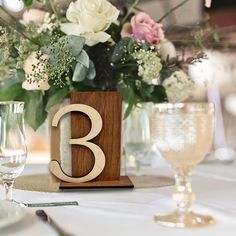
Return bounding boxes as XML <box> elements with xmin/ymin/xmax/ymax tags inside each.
<box><xmin>14</xmin><ymin>174</ymin><xmax>174</xmax><ymax>192</ymax></box>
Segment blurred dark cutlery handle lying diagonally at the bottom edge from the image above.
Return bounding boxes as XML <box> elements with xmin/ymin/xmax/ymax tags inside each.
<box><xmin>35</xmin><ymin>210</ymin><xmax>74</xmax><ymax>236</ymax></box>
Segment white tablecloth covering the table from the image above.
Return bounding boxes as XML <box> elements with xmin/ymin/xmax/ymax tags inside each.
<box><xmin>0</xmin><ymin>159</ymin><xmax>236</xmax><ymax>236</ymax></box>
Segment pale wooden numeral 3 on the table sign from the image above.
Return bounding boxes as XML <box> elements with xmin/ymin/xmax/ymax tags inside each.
<box><xmin>49</xmin><ymin>104</ymin><xmax>106</xmax><ymax>183</ymax></box>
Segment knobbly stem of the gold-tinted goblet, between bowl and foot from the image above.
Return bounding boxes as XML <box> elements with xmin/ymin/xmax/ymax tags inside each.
<box><xmin>173</xmin><ymin>168</ymin><xmax>195</xmax><ymax>214</ymax></box>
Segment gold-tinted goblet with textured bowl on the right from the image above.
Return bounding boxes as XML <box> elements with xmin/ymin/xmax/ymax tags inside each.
<box><xmin>151</xmin><ymin>103</ymin><xmax>214</xmax><ymax>228</ymax></box>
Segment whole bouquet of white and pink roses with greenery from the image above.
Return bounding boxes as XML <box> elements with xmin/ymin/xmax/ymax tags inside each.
<box><xmin>0</xmin><ymin>0</ymin><xmax>210</xmax><ymax>130</ymax></box>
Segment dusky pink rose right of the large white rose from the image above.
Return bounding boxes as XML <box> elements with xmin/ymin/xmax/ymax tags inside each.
<box><xmin>121</xmin><ymin>12</ymin><xmax>165</xmax><ymax>47</ymax></box>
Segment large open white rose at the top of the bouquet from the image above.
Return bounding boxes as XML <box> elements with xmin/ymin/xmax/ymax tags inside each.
<box><xmin>61</xmin><ymin>0</ymin><xmax>119</xmax><ymax>46</ymax></box>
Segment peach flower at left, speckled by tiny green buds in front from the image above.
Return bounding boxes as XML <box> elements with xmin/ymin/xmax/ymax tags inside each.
<box><xmin>22</xmin><ymin>52</ymin><xmax>50</xmax><ymax>90</ymax></box>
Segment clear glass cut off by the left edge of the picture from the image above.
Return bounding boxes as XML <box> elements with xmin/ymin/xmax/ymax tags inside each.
<box><xmin>0</xmin><ymin>101</ymin><xmax>27</xmax><ymax>201</ymax></box>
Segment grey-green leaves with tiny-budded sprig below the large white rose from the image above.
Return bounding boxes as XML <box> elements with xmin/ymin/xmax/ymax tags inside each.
<box><xmin>43</xmin><ymin>35</ymin><xmax>93</xmax><ymax>88</ymax></box>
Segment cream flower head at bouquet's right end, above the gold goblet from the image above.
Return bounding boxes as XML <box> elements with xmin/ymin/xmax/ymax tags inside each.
<box><xmin>162</xmin><ymin>70</ymin><xmax>195</xmax><ymax>102</ymax></box>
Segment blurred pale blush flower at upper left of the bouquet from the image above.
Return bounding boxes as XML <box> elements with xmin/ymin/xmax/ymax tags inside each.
<box><xmin>21</xmin><ymin>9</ymin><xmax>47</xmax><ymax>25</ymax></box>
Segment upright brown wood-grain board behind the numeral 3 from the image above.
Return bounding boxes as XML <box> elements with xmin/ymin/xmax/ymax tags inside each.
<box><xmin>71</xmin><ymin>92</ymin><xmax>122</xmax><ymax>181</ymax></box>
